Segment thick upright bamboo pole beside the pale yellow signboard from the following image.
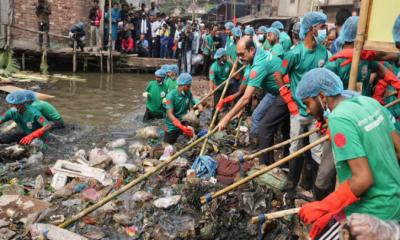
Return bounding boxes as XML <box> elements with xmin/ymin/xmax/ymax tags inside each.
<box><xmin>348</xmin><ymin>0</ymin><xmax>370</xmax><ymax>90</ymax></box>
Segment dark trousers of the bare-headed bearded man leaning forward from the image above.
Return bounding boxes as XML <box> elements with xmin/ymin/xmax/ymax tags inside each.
<box><xmin>258</xmin><ymin>96</ymin><xmax>290</xmax><ymax>165</ymax></box>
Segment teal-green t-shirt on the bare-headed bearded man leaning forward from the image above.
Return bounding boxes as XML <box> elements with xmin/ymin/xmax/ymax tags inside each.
<box><xmin>243</xmin><ymin>48</ymin><xmax>284</xmax><ymax>96</ymax></box>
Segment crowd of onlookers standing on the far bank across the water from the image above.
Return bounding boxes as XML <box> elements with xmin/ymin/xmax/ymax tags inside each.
<box><xmin>84</xmin><ymin>0</ymin><xmax>236</xmax><ymax>75</ymax></box>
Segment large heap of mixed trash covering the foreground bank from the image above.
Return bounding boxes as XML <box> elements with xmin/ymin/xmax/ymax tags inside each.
<box><xmin>0</xmin><ymin>123</ymin><xmax>301</xmax><ymax>240</ymax></box>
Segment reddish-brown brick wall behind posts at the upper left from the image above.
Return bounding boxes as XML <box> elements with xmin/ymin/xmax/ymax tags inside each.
<box><xmin>12</xmin><ymin>0</ymin><xmax>93</xmax><ymax>47</ymax></box>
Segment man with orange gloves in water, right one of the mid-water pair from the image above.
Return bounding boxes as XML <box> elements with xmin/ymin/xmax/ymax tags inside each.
<box><xmin>164</xmin><ymin>73</ymin><xmax>195</xmax><ymax>144</ymax></box>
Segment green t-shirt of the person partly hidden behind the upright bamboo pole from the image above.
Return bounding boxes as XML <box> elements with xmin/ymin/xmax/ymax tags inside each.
<box><xmin>325</xmin><ymin>58</ymin><xmax>378</xmax><ymax>97</ymax></box>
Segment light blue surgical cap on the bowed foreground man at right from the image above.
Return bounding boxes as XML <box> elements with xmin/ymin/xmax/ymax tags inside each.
<box><xmin>296</xmin><ymin>68</ymin><xmax>343</xmax><ymax>99</ymax></box>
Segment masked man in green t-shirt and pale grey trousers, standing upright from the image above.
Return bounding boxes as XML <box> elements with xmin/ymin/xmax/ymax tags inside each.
<box><xmin>279</xmin><ymin>12</ymin><xmax>328</xmax><ymax>189</ymax></box>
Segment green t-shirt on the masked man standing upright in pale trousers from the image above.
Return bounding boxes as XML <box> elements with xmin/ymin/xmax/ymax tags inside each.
<box><xmin>283</xmin><ymin>42</ymin><xmax>328</xmax><ymax>117</ymax></box>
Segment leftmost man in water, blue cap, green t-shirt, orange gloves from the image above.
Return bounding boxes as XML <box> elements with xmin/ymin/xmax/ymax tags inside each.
<box><xmin>0</xmin><ymin>90</ymin><xmax>52</xmax><ymax>145</ymax></box>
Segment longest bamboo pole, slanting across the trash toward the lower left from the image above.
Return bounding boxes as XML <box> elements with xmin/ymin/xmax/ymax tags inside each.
<box><xmin>59</xmin><ymin>127</ymin><xmax>217</xmax><ymax>228</ymax></box>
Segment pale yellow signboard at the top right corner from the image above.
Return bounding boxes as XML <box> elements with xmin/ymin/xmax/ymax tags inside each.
<box><xmin>364</xmin><ymin>0</ymin><xmax>400</xmax><ymax>52</ymax></box>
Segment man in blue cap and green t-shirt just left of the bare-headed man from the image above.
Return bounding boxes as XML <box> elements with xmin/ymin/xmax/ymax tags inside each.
<box><xmin>208</xmin><ymin>48</ymin><xmax>234</xmax><ymax>111</ymax></box>
